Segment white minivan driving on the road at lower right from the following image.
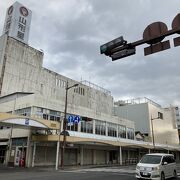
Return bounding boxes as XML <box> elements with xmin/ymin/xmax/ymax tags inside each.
<box><xmin>136</xmin><ymin>153</ymin><xmax>177</xmax><ymax>180</ymax></box>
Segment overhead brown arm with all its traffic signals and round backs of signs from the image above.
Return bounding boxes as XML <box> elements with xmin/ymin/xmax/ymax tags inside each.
<box><xmin>100</xmin><ymin>13</ymin><xmax>180</xmax><ymax>61</ymax></box>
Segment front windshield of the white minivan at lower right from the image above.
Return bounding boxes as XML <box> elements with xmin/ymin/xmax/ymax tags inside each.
<box><xmin>140</xmin><ymin>155</ymin><xmax>162</xmax><ymax>164</ymax></box>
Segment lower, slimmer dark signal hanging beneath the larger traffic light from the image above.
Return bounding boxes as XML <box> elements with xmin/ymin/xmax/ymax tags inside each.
<box><xmin>111</xmin><ymin>47</ymin><xmax>136</xmax><ymax>61</ymax></box>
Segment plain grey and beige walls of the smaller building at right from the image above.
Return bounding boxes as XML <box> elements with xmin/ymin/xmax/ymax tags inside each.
<box><xmin>114</xmin><ymin>103</ymin><xmax>179</xmax><ymax>145</ymax></box>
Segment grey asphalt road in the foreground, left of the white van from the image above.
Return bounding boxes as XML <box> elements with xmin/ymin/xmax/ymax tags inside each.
<box><xmin>0</xmin><ymin>167</ymin><xmax>180</xmax><ymax>180</ymax></box>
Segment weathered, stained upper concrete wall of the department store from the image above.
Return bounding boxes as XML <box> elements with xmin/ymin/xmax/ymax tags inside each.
<box><xmin>2</xmin><ymin>37</ymin><xmax>113</xmax><ymax>115</ymax></box>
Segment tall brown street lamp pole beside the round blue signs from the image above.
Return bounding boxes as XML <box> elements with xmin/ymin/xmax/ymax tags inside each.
<box><xmin>59</xmin><ymin>82</ymin><xmax>79</xmax><ymax>169</ymax></box>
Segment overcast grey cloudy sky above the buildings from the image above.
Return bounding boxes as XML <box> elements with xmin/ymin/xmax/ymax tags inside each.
<box><xmin>0</xmin><ymin>0</ymin><xmax>180</xmax><ymax>106</ymax></box>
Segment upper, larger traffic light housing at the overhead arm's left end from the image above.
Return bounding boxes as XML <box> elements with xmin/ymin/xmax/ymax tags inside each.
<box><xmin>100</xmin><ymin>36</ymin><xmax>127</xmax><ymax>56</ymax></box>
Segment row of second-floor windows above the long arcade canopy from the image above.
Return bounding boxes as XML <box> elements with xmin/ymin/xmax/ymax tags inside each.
<box><xmin>15</xmin><ymin>107</ymin><xmax>135</xmax><ymax>139</ymax></box>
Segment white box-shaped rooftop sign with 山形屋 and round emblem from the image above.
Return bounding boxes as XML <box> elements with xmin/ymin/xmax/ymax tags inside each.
<box><xmin>3</xmin><ymin>2</ymin><xmax>32</xmax><ymax>44</ymax></box>
